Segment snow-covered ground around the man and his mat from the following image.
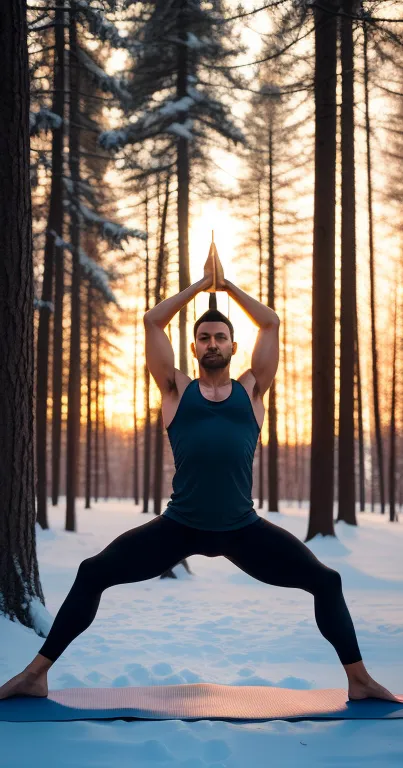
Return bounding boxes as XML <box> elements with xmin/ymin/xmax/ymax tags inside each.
<box><xmin>0</xmin><ymin>500</ymin><xmax>403</xmax><ymax>768</ymax></box>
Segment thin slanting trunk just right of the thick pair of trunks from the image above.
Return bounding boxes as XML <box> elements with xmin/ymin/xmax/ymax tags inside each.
<box><xmin>363</xmin><ymin>23</ymin><xmax>385</xmax><ymax>514</ymax></box>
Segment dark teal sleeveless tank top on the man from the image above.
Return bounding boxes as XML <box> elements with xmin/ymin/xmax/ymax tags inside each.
<box><xmin>162</xmin><ymin>379</ymin><xmax>260</xmax><ymax>531</ymax></box>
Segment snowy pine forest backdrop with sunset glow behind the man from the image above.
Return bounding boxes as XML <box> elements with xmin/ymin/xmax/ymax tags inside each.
<box><xmin>0</xmin><ymin>0</ymin><xmax>403</xmax><ymax>621</ymax></box>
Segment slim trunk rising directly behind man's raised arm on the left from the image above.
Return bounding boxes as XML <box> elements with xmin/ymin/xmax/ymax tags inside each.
<box><xmin>175</xmin><ymin>0</ymin><xmax>191</xmax><ymax>374</ymax></box>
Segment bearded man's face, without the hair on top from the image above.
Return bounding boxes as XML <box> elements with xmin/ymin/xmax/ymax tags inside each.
<box><xmin>191</xmin><ymin>321</ymin><xmax>236</xmax><ymax>370</ymax></box>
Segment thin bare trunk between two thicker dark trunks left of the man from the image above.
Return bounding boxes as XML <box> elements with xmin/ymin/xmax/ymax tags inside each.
<box><xmin>51</xmin><ymin>0</ymin><xmax>65</xmax><ymax>506</ymax></box>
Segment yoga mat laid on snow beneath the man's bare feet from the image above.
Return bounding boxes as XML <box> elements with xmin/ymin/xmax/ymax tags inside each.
<box><xmin>0</xmin><ymin>683</ymin><xmax>403</xmax><ymax>723</ymax></box>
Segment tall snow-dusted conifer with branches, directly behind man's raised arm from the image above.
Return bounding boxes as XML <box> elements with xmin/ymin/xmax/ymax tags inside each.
<box><xmin>100</xmin><ymin>0</ymin><xmax>244</xmax><ymax>373</ymax></box>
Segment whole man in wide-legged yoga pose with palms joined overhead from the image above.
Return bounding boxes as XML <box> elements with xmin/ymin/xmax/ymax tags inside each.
<box><xmin>0</xmin><ymin>268</ymin><xmax>400</xmax><ymax>701</ymax></box>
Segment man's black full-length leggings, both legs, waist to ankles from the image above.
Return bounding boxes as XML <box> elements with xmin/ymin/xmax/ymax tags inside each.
<box><xmin>39</xmin><ymin>515</ymin><xmax>361</xmax><ymax>664</ymax></box>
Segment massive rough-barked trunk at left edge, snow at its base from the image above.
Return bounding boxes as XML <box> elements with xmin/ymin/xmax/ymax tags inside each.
<box><xmin>0</xmin><ymin>0</ymin><xmax>45</xmax><ymax>637</ymax></box>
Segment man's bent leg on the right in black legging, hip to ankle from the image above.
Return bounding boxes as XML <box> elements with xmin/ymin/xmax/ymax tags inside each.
<box><xmin>222</xmin><ymin>518</ymin><xmax>362</xmax><ymax>664</ymax></box>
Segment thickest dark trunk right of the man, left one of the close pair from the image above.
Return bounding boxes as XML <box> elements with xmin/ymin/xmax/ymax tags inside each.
<box><xmin>305</xmin><ymin>0</ymin><xmax>337</xmax><ymax>541</ymax></box>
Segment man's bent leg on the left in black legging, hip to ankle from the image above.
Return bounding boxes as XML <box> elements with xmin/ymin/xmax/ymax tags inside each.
<box><xmin>38</xmin><ymin>516</ymin><xmax>196</xmax><ymax>661</ymax></box>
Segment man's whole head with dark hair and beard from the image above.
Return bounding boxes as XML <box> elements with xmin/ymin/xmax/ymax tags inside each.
<box><xmin>191</xmin><ymin>309</ymin><xmax>238</xmax><ymax>370</ymax></box>
